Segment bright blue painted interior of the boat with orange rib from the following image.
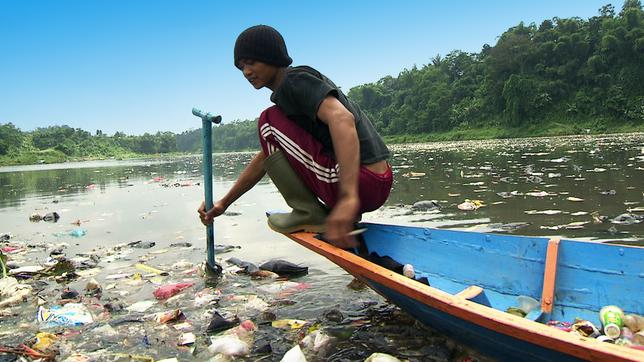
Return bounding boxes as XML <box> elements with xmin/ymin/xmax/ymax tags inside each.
<box><xmin>356</xmin><ymin>223</ymin><xmax>644</xmax><ymax>326</ymax></box>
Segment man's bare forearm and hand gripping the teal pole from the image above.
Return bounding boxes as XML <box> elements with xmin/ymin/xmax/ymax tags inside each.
<box><xmin>197</xmin><ymin>151</ymin><xmax>266</xmax><ymax>224</ymax></box>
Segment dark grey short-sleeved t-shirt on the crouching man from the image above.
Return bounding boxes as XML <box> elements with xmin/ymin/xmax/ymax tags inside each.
<box><xmin>271</xmin><ymin>66</ymin><xmax>389</xmax><ymax>164</ymax></box>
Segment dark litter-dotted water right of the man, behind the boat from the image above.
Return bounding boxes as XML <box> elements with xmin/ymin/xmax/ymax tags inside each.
<box><xmin>380</xmin><ymin>134</ymin><xmax>644</xmax><ymax>245</ymax></box>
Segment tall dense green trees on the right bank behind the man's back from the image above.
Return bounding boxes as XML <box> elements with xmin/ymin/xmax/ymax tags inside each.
<box><xmin>348</xmin><ymin>0</ymin><xmax>644</xmax><ymax>135</ymax></box>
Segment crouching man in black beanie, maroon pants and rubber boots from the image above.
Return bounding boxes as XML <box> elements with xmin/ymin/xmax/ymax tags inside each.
<box><xmin>198</xmin><ymin>25</ymin><xmax>393</xmax><ymax>248</ymax></box>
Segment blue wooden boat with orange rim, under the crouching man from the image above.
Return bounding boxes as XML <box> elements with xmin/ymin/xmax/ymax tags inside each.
<box><xmin>287</xmin><ymin>223</ymin><xmax>644</xmax><ymax>361</ymax></box>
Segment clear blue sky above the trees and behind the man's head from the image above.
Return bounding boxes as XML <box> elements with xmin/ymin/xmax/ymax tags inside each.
<box><xmin>0</xmin><ymin>0</ymin><xmax>622</xmax><ymax>134</ymax></box>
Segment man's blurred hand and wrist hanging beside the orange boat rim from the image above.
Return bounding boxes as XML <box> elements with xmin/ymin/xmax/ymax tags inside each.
<box><xmin>324</xmin><ymin>197</ymin><xmax>360</xmax><ymax>249</ymax></box>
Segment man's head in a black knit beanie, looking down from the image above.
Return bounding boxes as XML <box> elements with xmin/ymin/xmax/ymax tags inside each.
<box><xmin>235</xmin><ymin>25</ymin><xmax>293</xmax><ymax>89</ymax></box>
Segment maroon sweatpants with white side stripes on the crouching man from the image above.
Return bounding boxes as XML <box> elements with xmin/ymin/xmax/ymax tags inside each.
<box><xmin>258</xmin><ymin>106</ymin><xmax>393</xmax><ymax>213</ymax></box>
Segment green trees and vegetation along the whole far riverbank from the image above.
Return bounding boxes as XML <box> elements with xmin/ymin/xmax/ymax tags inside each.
<box><xmin>0</xmin><ymin>0</ymin><xmax>644</xmax><ymax>165</ymax></box>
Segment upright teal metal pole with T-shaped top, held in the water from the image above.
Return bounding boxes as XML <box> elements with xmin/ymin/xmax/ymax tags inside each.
<box><xmin>192</xmin><ymin>108</ymin><xmax>221</xmax><ymax>272</ymax></box>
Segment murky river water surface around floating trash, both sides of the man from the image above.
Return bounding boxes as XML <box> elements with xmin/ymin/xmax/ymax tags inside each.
<box><xmin>0</xmin><ymin>134</ymin><xmax>644</xmax><ymax>360</ymax></box>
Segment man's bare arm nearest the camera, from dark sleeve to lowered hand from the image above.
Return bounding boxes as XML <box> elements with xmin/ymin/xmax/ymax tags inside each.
<box><xmin>317</xmin><ymin>96</ymin><xmax>360</xmax><ymax>248</ymax></box>
